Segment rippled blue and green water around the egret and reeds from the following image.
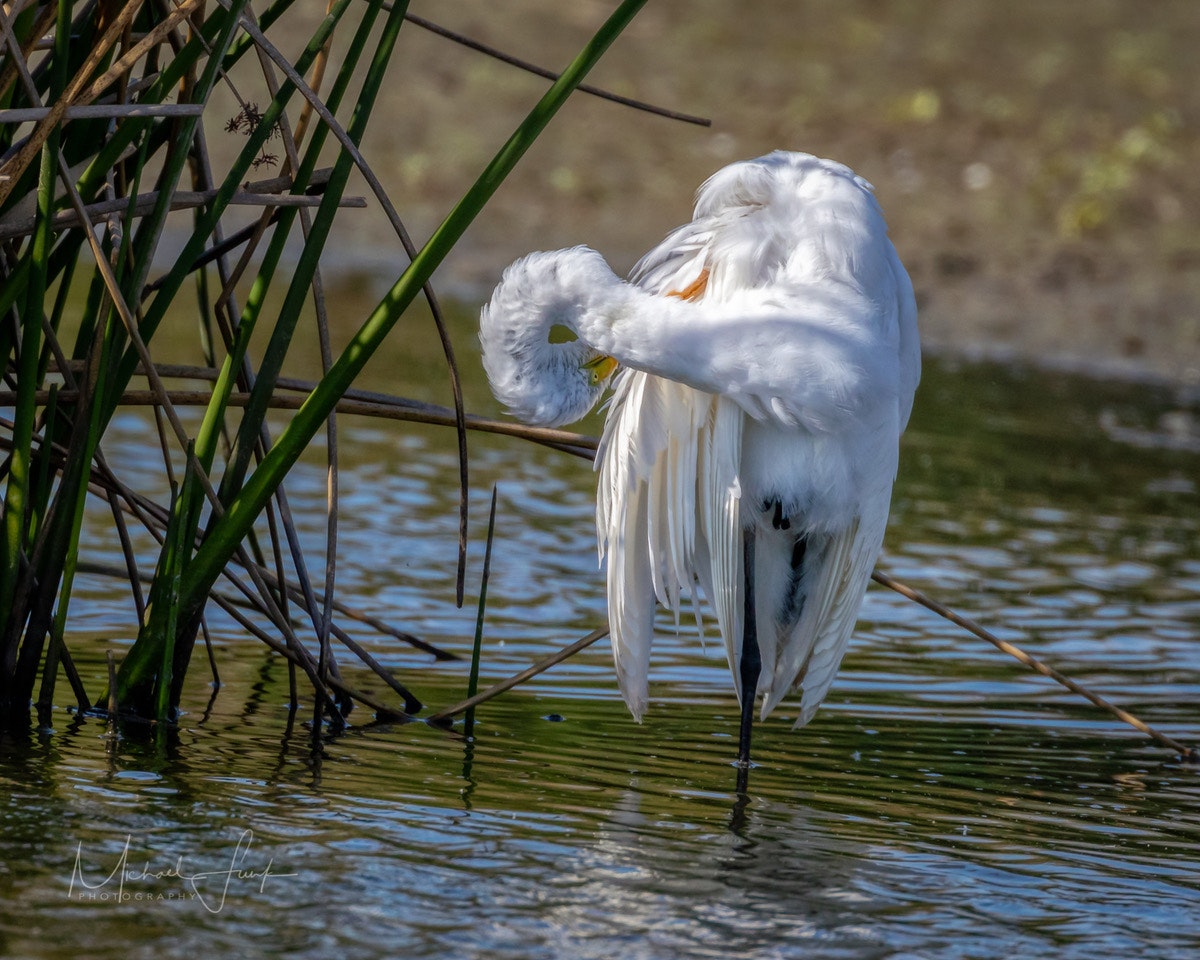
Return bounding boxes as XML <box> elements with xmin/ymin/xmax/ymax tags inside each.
<box><xmin>0</xmin><ymin>355</ymin><xmax>1200</xmax><ymax>960</ymax></box>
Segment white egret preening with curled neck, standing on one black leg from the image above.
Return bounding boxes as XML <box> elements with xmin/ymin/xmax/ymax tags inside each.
<box><xmin>480</xmin><ymin>151</ymin><xmax>920</xmax><ymax>764</ymax></box>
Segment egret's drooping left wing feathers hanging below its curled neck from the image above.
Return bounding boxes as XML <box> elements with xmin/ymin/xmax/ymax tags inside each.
<box><xmin>596</xmin><ymin>371</ymin><xmax>744</xmax><ymax>716</ymax></box>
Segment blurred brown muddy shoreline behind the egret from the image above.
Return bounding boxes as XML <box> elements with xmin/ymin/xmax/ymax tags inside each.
<box><xmin>212</xmin><ymin>0</ymin><xmax>1200</xmax><ymax>385</ymax></box>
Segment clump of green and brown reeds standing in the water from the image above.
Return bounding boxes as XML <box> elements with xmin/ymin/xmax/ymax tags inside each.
<box><xmin>0</xmin><ymin>0</ymin><xmax>644</xmax><ymax>726</ymax></box>
